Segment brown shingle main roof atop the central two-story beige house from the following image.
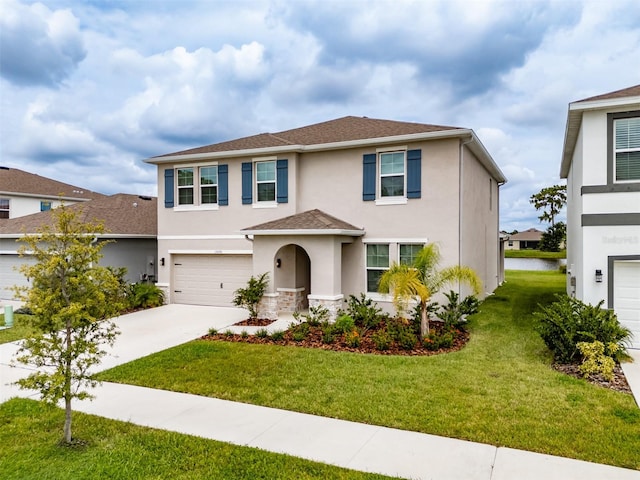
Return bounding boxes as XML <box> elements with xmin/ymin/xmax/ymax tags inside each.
<box><xmin>153</xmin><ymin>116</ymin><xmax>460</xmax><ymax>158</ymax></box>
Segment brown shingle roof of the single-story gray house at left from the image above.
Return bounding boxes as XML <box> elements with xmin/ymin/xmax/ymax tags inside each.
<box><xmin>0</xmin><ymin>193</ymin><xmax>158</xmax><ymax>238</ymax></box>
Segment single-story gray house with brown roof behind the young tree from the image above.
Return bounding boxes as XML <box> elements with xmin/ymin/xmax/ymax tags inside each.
<box><xmin>0</xmin><ymin>193</ymin><xmax>158</xmax><ymax>300</ymax></box>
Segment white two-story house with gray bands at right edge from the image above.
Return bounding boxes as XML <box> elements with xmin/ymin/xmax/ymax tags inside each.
<box><xmin>560</xmin><ymin>85</ymin><xmax>640</xmax><ymax>348</ymax></box>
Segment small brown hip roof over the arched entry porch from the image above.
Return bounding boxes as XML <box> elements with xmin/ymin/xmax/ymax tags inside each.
<box><xmin>242</xmin><ymin>209</ymin><xmax>364</xmax><ymax>236</ymax></box>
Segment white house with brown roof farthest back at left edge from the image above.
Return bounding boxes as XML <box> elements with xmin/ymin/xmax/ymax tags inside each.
<box><xmin>0</xmin><ymin>166</ymin><xmax>104</xmax><ymax>218</ymax></box>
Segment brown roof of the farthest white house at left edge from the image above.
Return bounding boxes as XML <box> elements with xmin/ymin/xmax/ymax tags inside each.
<box><xmin>0</xmin><ymin>167</ymin><xmax>104</xmax><ymax>201</ymax></box>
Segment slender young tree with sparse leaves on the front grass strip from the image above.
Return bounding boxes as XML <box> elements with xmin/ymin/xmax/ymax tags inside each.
<box><xmin>15</xmin><ymin>206</ymin><xmax>123</xmax><ymax>443</ymax></box>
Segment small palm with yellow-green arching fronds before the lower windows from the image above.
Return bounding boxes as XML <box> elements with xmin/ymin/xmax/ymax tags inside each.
<box><xmin>378</xmin><ymin>243</ymin><xmax>481</xmax><ymax>338</ymax></box>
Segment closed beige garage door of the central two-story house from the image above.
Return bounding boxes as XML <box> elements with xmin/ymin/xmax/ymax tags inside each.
<box><xmin>172</xmin><ymin>255</ymin><xmax>252</xmax><ymax>307</ymax></box>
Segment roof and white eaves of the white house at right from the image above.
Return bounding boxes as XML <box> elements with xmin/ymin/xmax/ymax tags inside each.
<box><xmin>560</xmin><ymin>85</ymin><xmax>640</xmax><ymax>178</ymax></box>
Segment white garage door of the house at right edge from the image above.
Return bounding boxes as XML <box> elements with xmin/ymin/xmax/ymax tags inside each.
<box><xmin>613</xmin><ymin>261</ymin><xmax>640</xmax><ymax>348</ymax></box>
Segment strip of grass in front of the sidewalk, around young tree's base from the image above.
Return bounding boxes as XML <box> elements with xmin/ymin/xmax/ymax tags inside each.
<box><xmin>0</xmin><ymin>399</ymin><xmax>396</xmax><ymax>480</ymax></box>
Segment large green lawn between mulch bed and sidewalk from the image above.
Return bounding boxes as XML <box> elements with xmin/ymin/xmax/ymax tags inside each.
<box><xmin>102</xmin><ymin>271</ymin><xmax>640</xmax><ymax>468</ymax></box>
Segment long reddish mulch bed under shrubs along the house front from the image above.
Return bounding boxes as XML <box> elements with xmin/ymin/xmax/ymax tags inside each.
<box><xmin>202</xmin><ymin>322</ymin><xmax>469</xmax><ymax>356</ymax></box>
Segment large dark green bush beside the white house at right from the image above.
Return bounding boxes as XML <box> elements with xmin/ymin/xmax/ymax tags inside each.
<box><xmin>534</xmin><ymin>295</ymin><xmax>631</xmax><ymax>363</ymax></box>
